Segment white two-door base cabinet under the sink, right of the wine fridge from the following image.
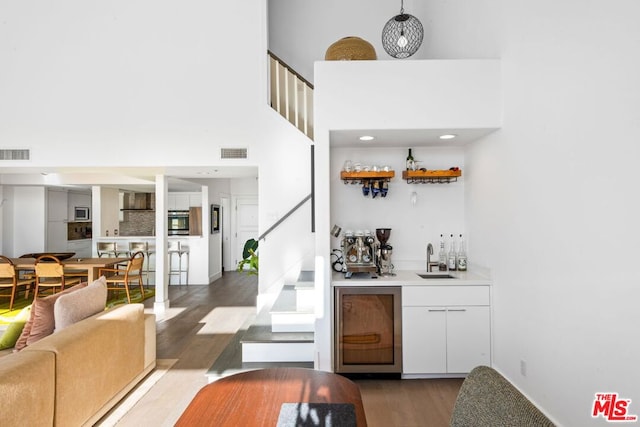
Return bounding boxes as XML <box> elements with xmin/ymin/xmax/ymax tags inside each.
<box><xmin>402</xmin><ymin>286</ymin><xmax>491</xmax><ymax>374</ymax></box>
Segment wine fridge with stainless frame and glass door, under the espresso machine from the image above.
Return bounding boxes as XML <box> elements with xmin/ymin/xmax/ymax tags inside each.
<box><xmin>334</xmin><ymin>286</ymin><xmax>402</xmax><ymax>373</ymax></box>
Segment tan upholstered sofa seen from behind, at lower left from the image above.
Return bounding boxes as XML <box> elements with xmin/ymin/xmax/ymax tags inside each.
<box><xmin>0</xmin><ymin>304</ymin><xmax>156</xmax><ymax>427</ymax></box>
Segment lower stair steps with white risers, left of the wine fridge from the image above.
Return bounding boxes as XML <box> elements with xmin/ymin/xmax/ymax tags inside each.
<box><xmin>206</xmin><ymin>271</ymin><xmax>315</xmax><ymax>382</ymax></box>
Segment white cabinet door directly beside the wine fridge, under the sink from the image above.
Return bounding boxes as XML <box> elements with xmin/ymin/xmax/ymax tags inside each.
<box><xmin>402</xmin><ymin>307</ymin><xmax>447</xmax><ymax>374</ymax></box>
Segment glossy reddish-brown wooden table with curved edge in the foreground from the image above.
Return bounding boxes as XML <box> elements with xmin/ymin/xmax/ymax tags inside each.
<box><xmin>176</xmin><ymin>368</ymin><xmax>367</xmax><ymax>427</ymax></box>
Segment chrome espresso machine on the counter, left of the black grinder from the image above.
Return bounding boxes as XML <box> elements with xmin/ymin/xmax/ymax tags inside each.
<box><xmin>341</xmin><ymin>230</ymin><xmax>378</xmax><ymax>279</ymax></box>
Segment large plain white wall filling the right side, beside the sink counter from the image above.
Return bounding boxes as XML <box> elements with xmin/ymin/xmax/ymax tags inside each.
<box><xmin>434</xmin><ymin>0</ymin><xmax>640</xmax><ymax>426</ymax></box>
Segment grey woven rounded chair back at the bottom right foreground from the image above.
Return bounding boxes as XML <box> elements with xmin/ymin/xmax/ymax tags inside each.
<box><xmin>451</xmin><ymin>366</ymin><xmax>554</xmax><ymax>427</ymax></box>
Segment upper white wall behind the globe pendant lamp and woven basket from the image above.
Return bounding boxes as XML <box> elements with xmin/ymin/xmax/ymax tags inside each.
<box><xmin>268</xmin><ymin>0</ymin><xmax>502</xmax><ymax>82</ymax></box>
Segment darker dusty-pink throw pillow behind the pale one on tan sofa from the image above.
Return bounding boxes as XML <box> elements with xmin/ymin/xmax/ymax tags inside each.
<box><xmin>15</xmin><ymin>283</ymin><xmax>87</xmax><ymax>351</ymax></box>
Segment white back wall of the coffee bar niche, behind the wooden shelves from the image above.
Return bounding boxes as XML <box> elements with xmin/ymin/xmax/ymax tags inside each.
<box><xmin>330</xmin><ymin>147</ymin><xmax>466</xmax><ymax>270</ymax></box>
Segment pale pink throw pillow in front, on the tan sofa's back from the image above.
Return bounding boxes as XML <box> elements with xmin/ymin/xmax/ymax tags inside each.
<box><xmin>53</xmin><ymin>276</ymin><xmax>107</xmax><ymax>332</ymax></box>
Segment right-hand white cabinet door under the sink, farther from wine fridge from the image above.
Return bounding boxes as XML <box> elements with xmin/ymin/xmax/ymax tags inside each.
<box><xmin>447</xmin><ymin>306</ymin><xmax>491</xmax><ymax>373</ymax></box>
